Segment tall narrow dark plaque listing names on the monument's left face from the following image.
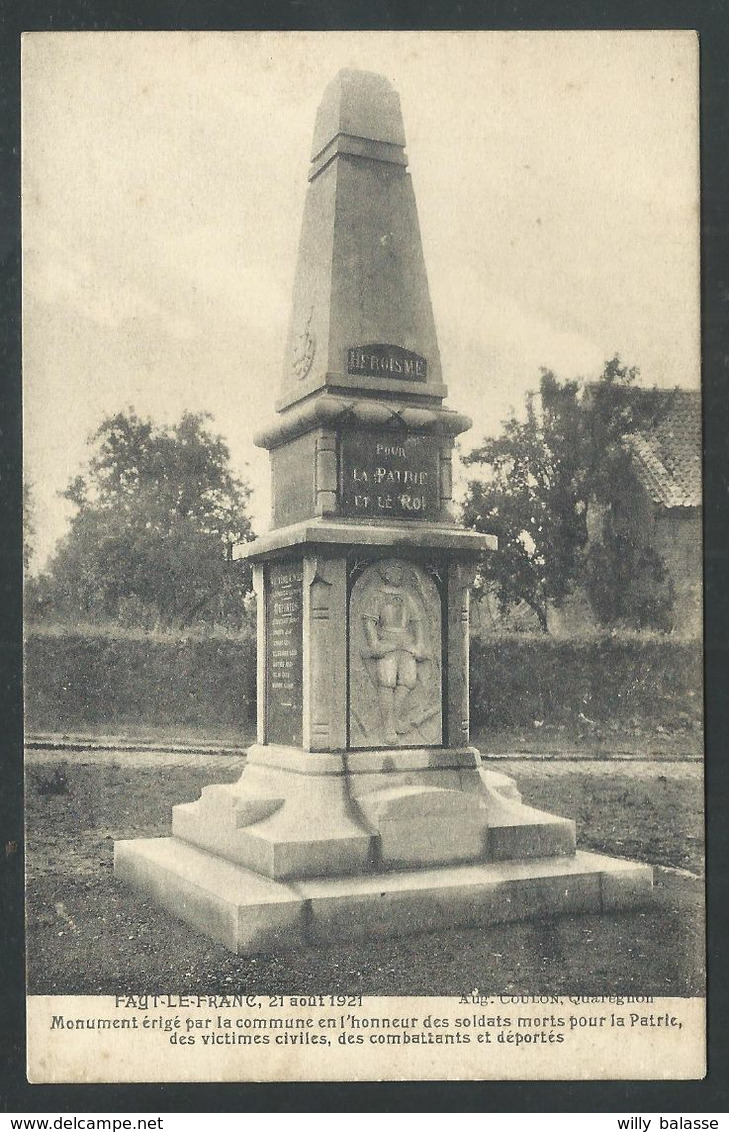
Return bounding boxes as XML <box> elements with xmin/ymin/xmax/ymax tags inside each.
<box><xmin>266</xmin><ymin>563</ymin><xmax>303</xmax><ymax>746</ymax></box>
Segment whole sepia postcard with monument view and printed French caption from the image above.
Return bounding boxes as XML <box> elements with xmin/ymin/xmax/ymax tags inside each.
<box><xmin>22</xmin><ymin>31</ymin><xmax>705</xmax><ymax>1083</ymax></box>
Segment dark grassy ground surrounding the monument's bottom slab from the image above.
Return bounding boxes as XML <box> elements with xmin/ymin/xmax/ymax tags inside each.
<box><xmin>27</xmin><ymin>757</ymin><xmax>703</xmax><ymax>995</ymax></box>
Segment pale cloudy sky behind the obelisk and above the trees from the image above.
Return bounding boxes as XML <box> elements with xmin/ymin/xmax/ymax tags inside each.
<box><xmin>23</xmin><ymin>32</ymin><xmax>700</xmax><ymax>565</ymax></box>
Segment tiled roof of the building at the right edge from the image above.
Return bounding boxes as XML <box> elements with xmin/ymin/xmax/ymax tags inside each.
<box><xmin>629</xmin><ymin>389</ymin><xmax>702</xmax><ymax>507</ymax></box>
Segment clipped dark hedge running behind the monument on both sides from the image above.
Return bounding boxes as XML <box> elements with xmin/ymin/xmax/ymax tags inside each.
<box><xmin>26</xmin><ymin>629</ymin><xmax>702</xmax><ymax>737</ymax></box>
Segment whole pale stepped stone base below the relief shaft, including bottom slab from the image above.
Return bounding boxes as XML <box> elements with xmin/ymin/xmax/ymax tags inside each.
<box><xmin>114</xmin><ymin>745</ymin><xmax>653</xmax><ymax>954</ymax></box>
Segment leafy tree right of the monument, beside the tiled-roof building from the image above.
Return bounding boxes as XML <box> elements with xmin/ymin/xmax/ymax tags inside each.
<box><xmin>463</xmin><ymin>357</ymin><xmax>670</xmax><ymax>632</ymax></box>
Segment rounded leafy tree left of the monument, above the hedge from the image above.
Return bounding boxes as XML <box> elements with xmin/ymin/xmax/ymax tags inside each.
<box><xmin>41</xmin><ymin>410</ymin><xmax>251</xmax><ymax>626</ymax></box>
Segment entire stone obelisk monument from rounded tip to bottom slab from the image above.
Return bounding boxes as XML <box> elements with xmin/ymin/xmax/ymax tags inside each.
<box><xmin>115</xmin><ymin>71</ymin><xmax>652</xmax><ymax>952</ymax></box>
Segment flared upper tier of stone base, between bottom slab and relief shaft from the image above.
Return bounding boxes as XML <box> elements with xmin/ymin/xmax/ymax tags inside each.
<box><xmin>167</xmin><ymin>744</ymin><xmax>575</xmax><ymax>881</ymax></box>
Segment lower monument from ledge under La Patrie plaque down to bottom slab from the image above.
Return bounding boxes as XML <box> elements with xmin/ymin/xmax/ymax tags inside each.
<box><xmin>114</xmin><ymin>529</ymin><xmax>652</xmax><ymax>954</ymax></box>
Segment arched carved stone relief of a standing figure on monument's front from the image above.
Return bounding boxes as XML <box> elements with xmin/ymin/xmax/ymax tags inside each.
<box><xmin>349</xmin><ymin>558</ymin><xmax>443</xmax><ymax>747</ymax></box>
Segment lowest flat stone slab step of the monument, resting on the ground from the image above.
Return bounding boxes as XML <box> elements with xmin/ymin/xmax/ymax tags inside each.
<box><xmin>114</xmin><ymin>838</ymin><xmax>653</xmax><ymax>954</ymax></box>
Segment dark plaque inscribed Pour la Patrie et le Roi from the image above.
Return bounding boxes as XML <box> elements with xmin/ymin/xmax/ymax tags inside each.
<box><xmin>340</xmin><ymin>429</ymin><xmax>440</xmax><ymax>520</ymax></box>
